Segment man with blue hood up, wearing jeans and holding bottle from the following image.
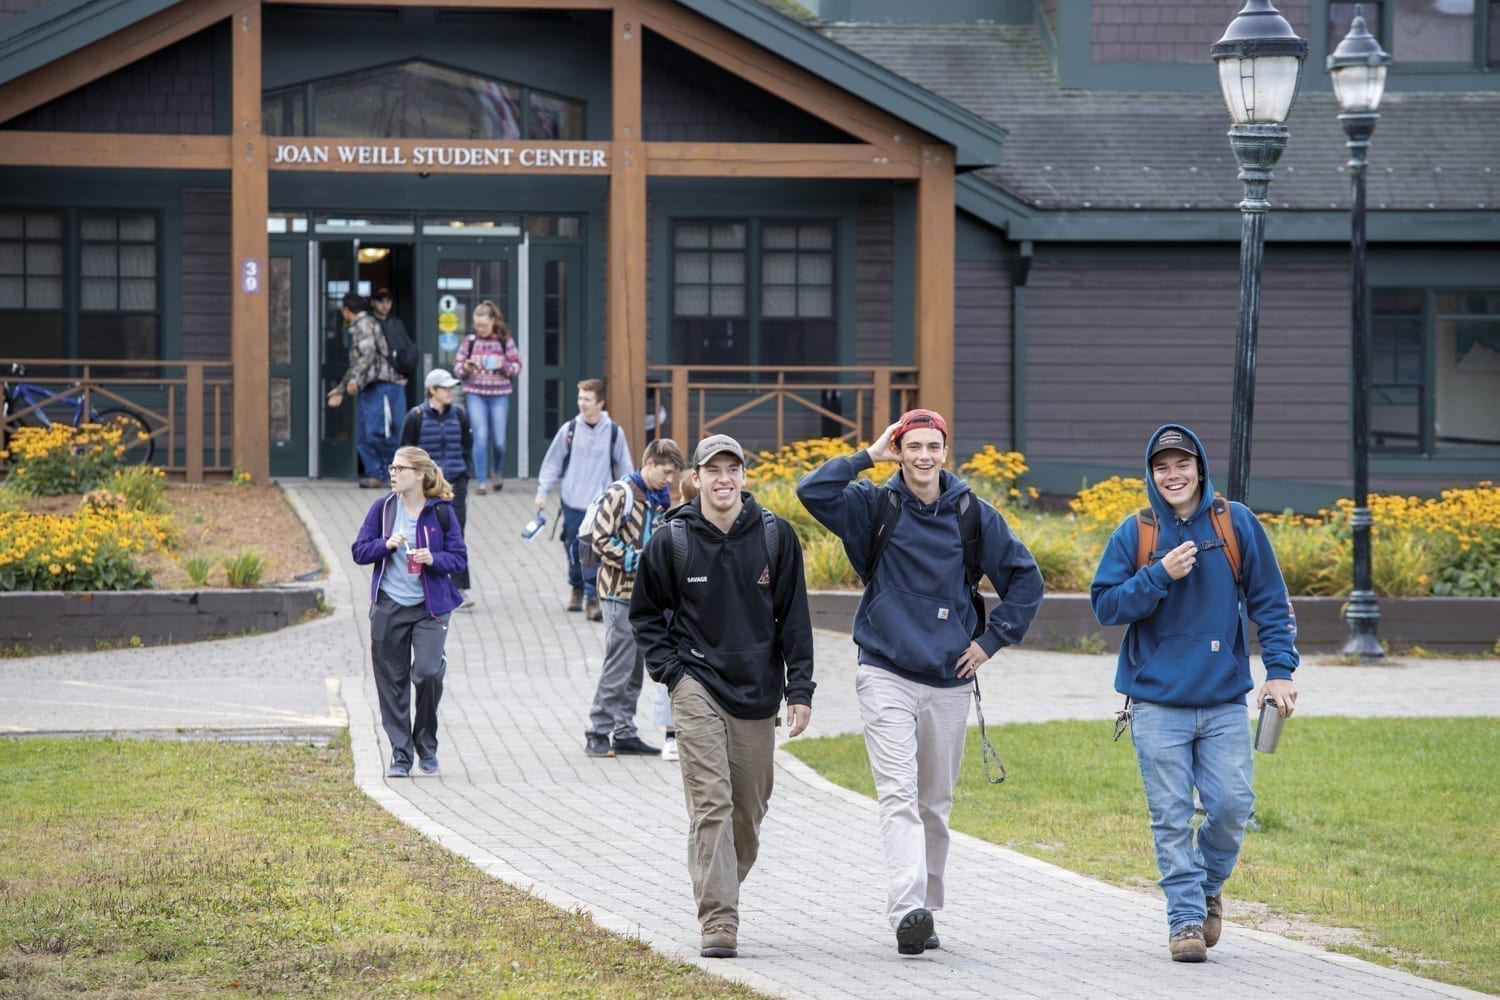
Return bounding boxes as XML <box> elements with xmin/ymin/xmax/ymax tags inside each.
<box><xmin>1091</xmin><ymin>424</ymin><xmax>1298</xmax><ymax>963</ymax></box>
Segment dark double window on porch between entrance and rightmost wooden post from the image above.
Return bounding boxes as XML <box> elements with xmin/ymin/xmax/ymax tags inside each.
<box><xmin>671</xmin><ymin>220</ymin><xmax>839</xmax><ymax>367</ymax></box>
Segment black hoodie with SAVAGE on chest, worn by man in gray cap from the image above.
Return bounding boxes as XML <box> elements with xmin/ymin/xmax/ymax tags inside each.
<box><xmin>630</xmin><ymin>493</ymin><xmax>815</xmax><ymax>718</ymax></box>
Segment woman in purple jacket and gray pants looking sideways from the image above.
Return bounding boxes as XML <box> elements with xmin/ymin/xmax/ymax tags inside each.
<box><xmin>351</xmin><ymin>447</ymin><xmax>468</xmax><ymax>778</ymax></box>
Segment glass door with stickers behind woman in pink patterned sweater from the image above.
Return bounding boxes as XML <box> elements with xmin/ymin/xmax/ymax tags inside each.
<box><xmin>416</xmin><ymin>238</ymin><xmax>530</xmax><ymax>478</ymax></box>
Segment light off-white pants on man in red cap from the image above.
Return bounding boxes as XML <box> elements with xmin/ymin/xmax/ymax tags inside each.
<box><xmin>854</xmin><ymin>664</ymin><xmax>971</xmax><ymax>930</ymax></box>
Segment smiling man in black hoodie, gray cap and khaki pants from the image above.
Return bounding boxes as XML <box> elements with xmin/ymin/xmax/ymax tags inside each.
<box><xmin>630</xmin><ymin>435</ymin><xmax>813</xmax><ymax>958</ymax></box>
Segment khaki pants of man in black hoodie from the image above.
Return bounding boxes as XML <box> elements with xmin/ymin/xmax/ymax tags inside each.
<box><xmin>672</xmin><ymin>676</ymin><xmax>776</xmax><ymax>930</ymax></box>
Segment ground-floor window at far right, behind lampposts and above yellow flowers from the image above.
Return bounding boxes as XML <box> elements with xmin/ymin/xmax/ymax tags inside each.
<box><xmin>1370</xmin><ymin>288</ymin><xmax>1500</xmax><ymax>456</ymax></box>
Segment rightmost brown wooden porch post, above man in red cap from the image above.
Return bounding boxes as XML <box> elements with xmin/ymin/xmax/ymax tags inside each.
<box><xmin>906</xmin><ymin>145</ymin><xmax>954</xmax><ymax>433</ymax></box>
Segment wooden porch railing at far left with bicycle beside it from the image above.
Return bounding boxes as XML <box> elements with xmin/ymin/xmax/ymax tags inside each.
<box><xmin>0</xmin><ymin>358</ymin><xmax>234</xmax><ymax>483</ymax></box>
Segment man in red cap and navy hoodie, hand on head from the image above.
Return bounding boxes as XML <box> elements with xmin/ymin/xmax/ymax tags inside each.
<box><xmin>797</xmin><ymin>409</ymin><xmax>1043</xmax><ymax>955</ymax></box>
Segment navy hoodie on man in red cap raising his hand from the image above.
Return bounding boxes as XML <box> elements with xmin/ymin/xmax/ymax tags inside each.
<box><xmin>797</xmin><ymin>451</ymin><xmax>1043</xmax><ymax>687</ymax></box>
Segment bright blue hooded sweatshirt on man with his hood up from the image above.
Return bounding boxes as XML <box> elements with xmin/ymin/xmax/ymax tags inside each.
<box><xmin>1089</xmin><ymin>424</ymin><xmax>1298</xmax><ymax>708</ymax></box>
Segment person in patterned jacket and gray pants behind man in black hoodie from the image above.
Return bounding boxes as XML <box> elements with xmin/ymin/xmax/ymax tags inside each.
<box><xmin>584</xmin><ymin>438</ymin><xmax>687</xmax><ymax>757</ymax></box>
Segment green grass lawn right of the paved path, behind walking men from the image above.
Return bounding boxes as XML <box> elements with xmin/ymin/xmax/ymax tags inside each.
<box><xmin>786</xmin><ymin>717</ymin><xmax>1500</xmax><ymax>993</ymax></box>
